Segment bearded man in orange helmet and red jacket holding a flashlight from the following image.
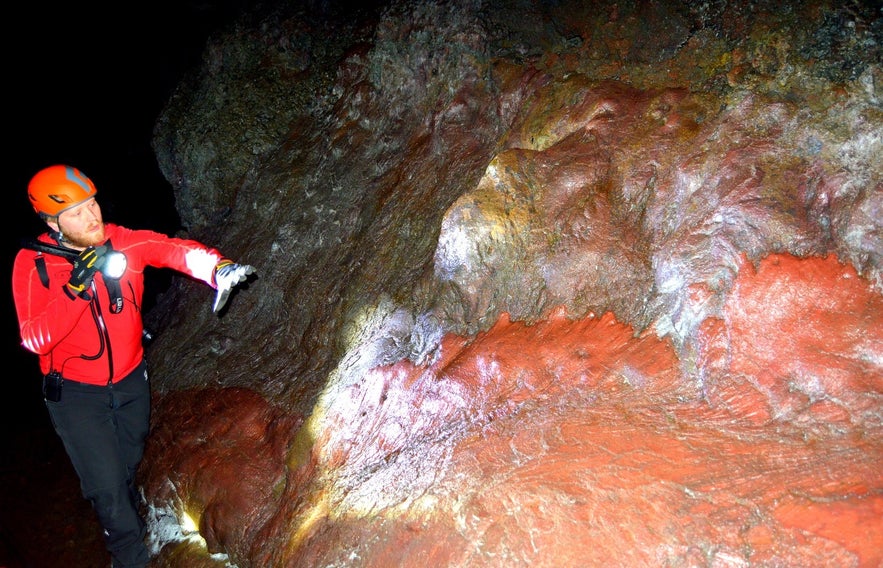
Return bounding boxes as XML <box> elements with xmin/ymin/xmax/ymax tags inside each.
<box><xmin>12</xmin><ymin>165</ymin><xmax>254</xmax><ymax>567</ymax></box>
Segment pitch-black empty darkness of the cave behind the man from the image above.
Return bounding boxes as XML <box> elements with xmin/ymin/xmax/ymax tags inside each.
<box><xmin>0</xmin><ymin>0</ymin><xmax>247</xmax><ymax>430</ymax></box>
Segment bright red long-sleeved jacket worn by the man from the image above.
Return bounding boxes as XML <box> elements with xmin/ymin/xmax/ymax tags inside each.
<box><xmin>12</xmin><ymin>223</ymin><xmax>224</xmax><ymax>385</ymax></box>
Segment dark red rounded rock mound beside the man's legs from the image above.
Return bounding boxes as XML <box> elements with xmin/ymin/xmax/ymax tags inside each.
<box><xmin>143</xmin><ymin>389</ymin><xmax>302</xmax><ymax>563</ymax></box>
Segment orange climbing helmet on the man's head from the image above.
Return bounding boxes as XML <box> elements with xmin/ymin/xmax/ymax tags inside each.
<box><xmin>28</xmin><ymin>164</ymin><xmax>98</xmax><ymax>217</ymax></box>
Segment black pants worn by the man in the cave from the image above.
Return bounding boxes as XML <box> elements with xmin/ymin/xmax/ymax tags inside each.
<box><xmin>46</xmin><ymin>362</ymin><xmax>150</xmax><ymax>567</ymax></box>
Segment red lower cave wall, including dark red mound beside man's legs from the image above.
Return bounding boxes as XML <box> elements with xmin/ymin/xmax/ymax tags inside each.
<box><xmin>143</xmin><ymin>255</ymin><xmax>883</xmax><ymax>568</ymax></box>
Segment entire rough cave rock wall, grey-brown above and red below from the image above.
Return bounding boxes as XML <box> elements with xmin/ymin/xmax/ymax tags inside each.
<box><xmin>142</xmin><ymin>1</ymin><xmax>883</xmax><ymax>567</ymax></box>
